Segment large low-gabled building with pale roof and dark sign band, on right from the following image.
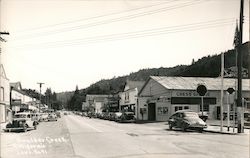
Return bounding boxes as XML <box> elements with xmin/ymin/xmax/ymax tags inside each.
<box><xmin>138</xmin><ymin>76</ymin><xmax>250</xmax><ymax>121</ymax></box>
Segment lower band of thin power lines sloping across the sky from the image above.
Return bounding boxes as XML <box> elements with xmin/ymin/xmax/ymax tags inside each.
<box><xmin>9</xmin><ymin>19</ymin><xmax>234</xmax><ymax>49</ymax></box>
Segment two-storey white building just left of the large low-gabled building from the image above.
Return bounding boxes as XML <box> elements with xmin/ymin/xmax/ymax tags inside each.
<box><xmin>119</xmin><ymin>80</ymin><xmax>145</xmax><ymax>117</ymax></box>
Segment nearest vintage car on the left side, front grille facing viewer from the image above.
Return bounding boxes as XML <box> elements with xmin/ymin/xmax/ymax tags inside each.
<box><xmin>5</xmin><ymin>112</ymin><xmax>38</xmax><ymax>132</ymax></box>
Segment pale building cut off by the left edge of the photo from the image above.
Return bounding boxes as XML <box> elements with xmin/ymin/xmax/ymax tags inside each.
<box><xmin>0</xmin><ymin>64</ymin><xmax>11</xmax><ymax>123</ymax></box>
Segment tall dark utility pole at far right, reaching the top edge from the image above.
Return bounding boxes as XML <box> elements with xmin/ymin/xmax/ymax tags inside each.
<box><xmin>236</xmin><ymin>0</ymin><xmax>244</xmax><ymax>133</ymax></box>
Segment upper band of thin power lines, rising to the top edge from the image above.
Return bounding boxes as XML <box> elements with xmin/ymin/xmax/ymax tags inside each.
<box><xmin>12</xmin><ymin>0</ymin><xmax>205</xmax><ymax>40</ymax></box>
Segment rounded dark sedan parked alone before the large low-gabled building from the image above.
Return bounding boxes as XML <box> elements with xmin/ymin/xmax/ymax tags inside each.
<box><xmin>168</xmin><ymin>110</ymin><xmax>207</xmax><ymax>132</ymax></box>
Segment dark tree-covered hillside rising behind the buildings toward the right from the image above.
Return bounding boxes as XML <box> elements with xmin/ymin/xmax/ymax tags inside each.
<box><xmin>57</xmin><ymin>42</ymin><xmax>250</xmax><ymax>109</ymax></box>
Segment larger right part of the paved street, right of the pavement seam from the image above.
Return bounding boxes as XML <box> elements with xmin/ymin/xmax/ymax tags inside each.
<box><xmin>66</xmin><ymin>115</ymin><xmax>249</xmax><ymax>158</ymax></box>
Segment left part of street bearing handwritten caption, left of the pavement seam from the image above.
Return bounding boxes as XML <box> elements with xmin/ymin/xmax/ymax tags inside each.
<box><xmin>1</xmin><ymin>118</ymin><xmax>74</xmax><ymax>158</ymax></box>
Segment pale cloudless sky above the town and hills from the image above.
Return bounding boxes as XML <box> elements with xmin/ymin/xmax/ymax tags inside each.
<box><xmin>0</xmin><ymin>0</ymin><xmax>249</xmax><ymax>92</ymax></box>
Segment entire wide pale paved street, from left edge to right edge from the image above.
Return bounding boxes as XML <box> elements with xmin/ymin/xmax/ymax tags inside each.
<box><xmin>1</xmin><ymin>114</ymin><xmax>249</xmax><ymax>158</ymax></box>
